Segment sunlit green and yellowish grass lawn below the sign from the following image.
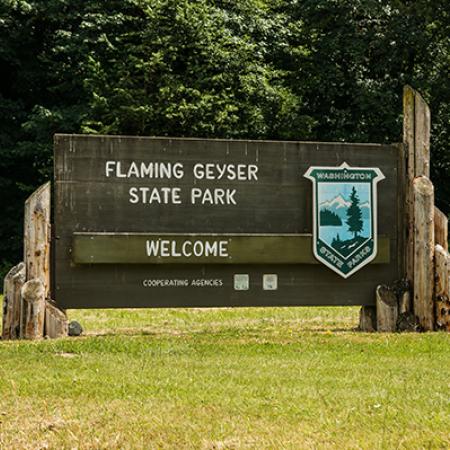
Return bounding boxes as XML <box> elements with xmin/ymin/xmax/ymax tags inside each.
<box><xmin>0</xmin><ymin>308</ymin><xmax>450</xmax><ymax>449</ymax></box>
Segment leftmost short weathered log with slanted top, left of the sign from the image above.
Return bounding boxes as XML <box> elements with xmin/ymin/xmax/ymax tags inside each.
<box><xmin>2</xmin><ymin>263</ymin><xmax>25</xmax><ymax>339</ymax></box>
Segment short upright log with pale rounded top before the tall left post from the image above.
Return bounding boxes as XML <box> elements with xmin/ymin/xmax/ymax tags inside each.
<box><xmin>22</xmin><ymin>278</ymin><xmax>45</xmax><ymax>339</ymax></box>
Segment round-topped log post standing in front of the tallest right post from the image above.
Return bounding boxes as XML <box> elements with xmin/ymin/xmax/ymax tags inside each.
<box><xmin>414</xmin><ymin>177</ymin><xmax>434</xmax><ymax>330</ymax></box>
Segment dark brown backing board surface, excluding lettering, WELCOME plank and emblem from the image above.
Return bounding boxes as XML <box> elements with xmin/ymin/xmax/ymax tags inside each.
<box><xmin>54</xmin><ymin>135</ymin><xmax>405</xmax><ymax>309</ymax></box>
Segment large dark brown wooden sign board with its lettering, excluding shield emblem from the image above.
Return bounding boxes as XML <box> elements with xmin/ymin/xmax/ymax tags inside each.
<box><xmin>52</xmin><ymin>135</ymin><xmax>405</xmax><ymax>308</ymax></box>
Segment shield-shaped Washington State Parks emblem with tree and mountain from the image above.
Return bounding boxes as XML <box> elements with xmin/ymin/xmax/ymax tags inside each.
<box><xmin>304</xmin><ymin>162</ymin><xmax>385</xmax><ymax>278</ymax></box>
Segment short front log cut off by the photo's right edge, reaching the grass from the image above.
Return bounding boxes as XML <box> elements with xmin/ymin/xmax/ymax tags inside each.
<box><xmin>434</xmin><ymin>245</ymin><xmax>450</xmax><ymax>331</ymax></box>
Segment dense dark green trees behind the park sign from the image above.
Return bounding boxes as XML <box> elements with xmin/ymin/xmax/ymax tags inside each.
<box><xmin>0</xmin><ymin>0</ymin><xmax>450</xmax><ymax>275</ymax></box>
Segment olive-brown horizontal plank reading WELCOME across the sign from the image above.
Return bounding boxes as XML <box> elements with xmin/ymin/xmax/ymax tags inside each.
<box><xmin>72</xmin><ymin>233</ymin><xmax>389</xmax><ymax>264</ymax></box>
